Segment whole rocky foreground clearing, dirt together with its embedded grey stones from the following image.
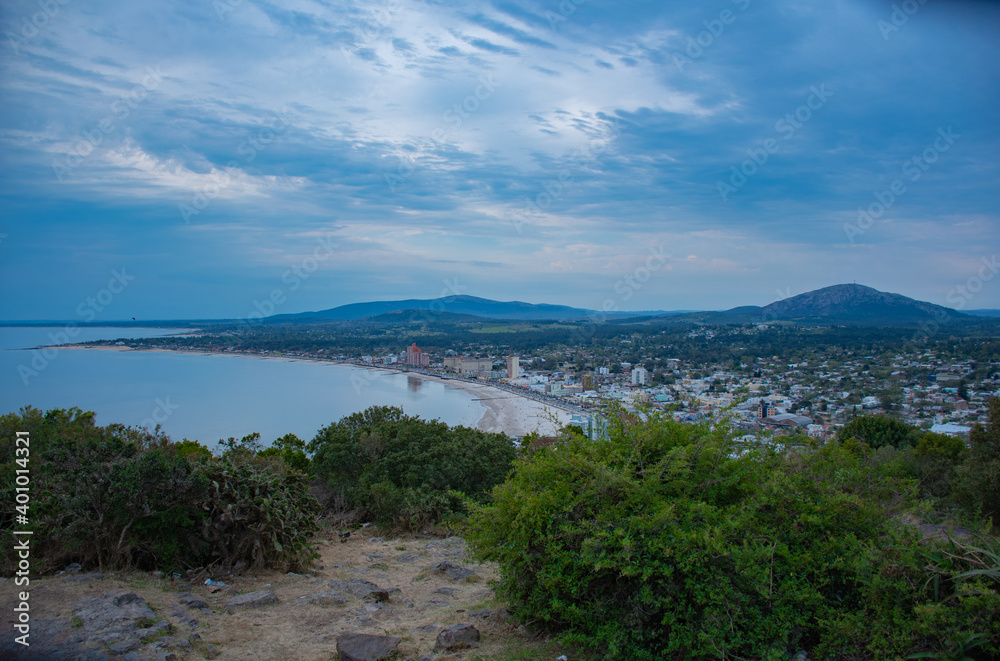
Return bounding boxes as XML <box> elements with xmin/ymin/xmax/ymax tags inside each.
<box><xmin>0</xmin><ymin>529</ymin><xmax>579</xmax><ymax>661</ymax></box>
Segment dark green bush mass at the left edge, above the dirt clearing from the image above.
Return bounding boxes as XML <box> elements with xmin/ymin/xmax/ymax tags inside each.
<box><xmin>0</xmin><ymin>408</ymin><xmax>318</xmax><ymax>575</ymax></box>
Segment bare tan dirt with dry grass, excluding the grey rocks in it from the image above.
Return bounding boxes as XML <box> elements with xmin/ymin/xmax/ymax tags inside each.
<box><xmin>0</xmin><ymin>528</ymin><xmax>572</xmax><ymax>661</ymax></box>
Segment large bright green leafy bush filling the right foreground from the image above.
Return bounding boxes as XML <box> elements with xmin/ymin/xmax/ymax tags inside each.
<box><xmin>469</xmin><ymin>416</ymin><xmax>1000</xmax><ymax>660</ymax></box>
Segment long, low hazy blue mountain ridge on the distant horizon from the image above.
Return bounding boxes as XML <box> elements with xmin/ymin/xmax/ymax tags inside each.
<box><xmin>267</xmin><ymin>295</ymin><xmax>669</xmax><ymax>323</ymax></box>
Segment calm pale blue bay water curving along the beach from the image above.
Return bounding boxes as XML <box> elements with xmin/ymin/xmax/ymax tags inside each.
<box><xmin>0</xmin><ymin>328</ymin><xmax>484</xmax><ymax>446</ymax></box>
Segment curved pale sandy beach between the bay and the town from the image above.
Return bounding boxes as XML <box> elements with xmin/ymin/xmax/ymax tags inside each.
<box><xmin>57</xmin><ymin>344</ymin><xmax>570</xmax><ymax>437</ymax></box>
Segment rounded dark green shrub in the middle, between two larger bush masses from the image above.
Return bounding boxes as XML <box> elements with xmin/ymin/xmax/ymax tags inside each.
<box><xmin>309</xmin><ymin>406</ymin><xmax>515</xmax><ymax>528</ymax></box>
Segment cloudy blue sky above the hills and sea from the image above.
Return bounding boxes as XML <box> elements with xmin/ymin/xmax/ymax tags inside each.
<box><xmin>0</xmin><ymin>0</ymin><xmax>1000</xmax><ymax>322</ymax></box>
